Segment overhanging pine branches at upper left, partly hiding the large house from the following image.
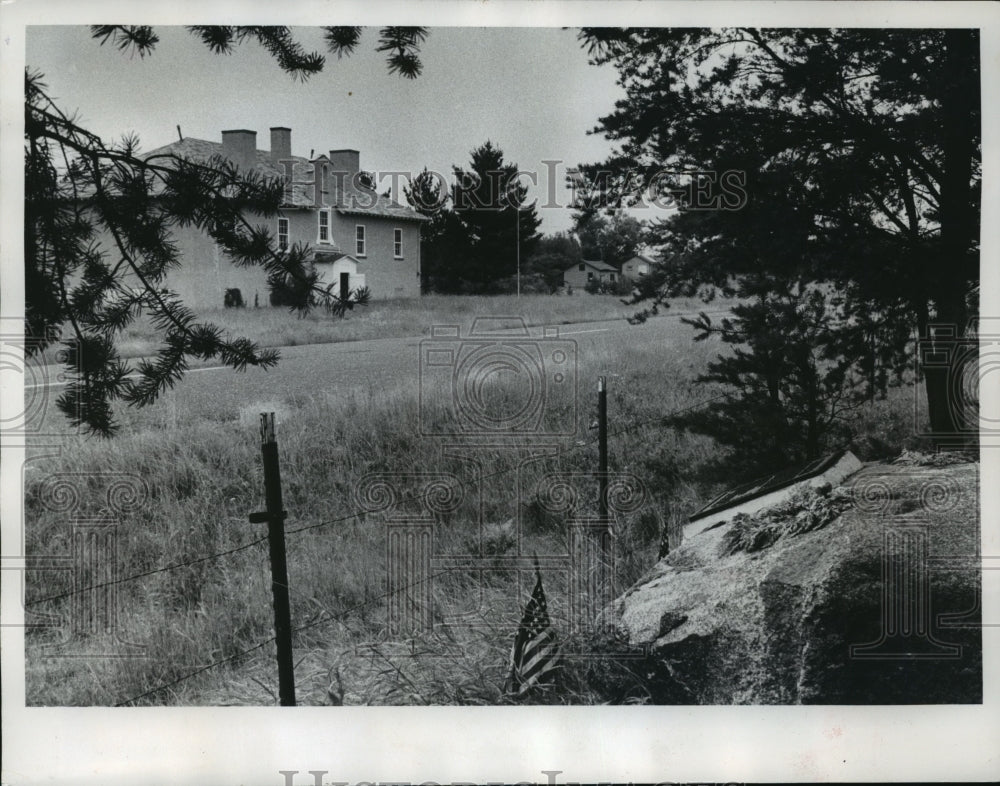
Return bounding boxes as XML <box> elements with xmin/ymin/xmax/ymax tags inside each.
<box><xmin>24</xmin><ymin>25</ymin><xmax>426</xmax><ymax>435</ymax></box>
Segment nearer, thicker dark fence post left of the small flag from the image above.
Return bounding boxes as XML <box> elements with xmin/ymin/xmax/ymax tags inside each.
<box><xmin>250</xmin><ymin>412</ymin><xmax>295</xmax><ymax>707</ymax></box>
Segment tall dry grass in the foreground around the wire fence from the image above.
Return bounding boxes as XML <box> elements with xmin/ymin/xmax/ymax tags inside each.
<box><xmin>19</xmin><ymin>298</ymin><xmax>920</xmax><ymax>705</ymax></box>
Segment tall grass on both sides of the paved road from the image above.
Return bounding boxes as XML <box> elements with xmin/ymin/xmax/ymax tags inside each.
<box><xmin>25</xmin><ymin>296</ymin><xmax>928</xmax><ymax>706</ymax></box>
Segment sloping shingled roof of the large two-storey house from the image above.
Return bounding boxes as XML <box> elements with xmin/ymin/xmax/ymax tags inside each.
<box><xmin>144</xmin><ymin>137</ymin><xmax>430</xmax><ymax>221</ymax></box>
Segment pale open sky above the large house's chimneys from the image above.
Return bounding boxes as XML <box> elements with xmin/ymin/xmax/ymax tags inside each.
<box><xmin>26</xmin><ymin>25</ymin><xmax>623</xmax><ymax>233</ymax></box>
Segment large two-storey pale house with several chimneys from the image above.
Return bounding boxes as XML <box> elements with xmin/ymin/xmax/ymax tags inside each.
<box><xmin>139</xmin><ymin>126</ymin><xmax>428</xmax><ymax>310</ymax></box>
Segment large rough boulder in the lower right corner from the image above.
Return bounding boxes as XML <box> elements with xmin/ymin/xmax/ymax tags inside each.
<box><xmin>615</xmin><ymin>456</ymin><xmax>982</xmax><ymax>704</ymax></box>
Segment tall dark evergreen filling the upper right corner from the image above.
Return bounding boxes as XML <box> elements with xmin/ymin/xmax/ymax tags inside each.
<box><xmin>581</xmin><ymin>28</ymin><xmax>981</xmax><ymax>448</ymax></box>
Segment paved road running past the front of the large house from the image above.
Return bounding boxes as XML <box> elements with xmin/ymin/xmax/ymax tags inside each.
<box><xmin>25</xmin><ymin>313</ymin><xmax>724</xmax><ymax>431</ymax></box>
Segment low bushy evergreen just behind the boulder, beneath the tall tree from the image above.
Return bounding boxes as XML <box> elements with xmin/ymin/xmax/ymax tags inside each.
<box><xmin>672</xmin><ymin>279</ymin><xmax>916</xmax><ymax>480</ymax></box>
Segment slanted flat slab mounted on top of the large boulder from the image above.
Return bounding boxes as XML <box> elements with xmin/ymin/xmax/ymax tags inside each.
<box><xmin>684</xmin><ymin>450</ymin><xmax>862</xmax><ymax>538</ymax></box>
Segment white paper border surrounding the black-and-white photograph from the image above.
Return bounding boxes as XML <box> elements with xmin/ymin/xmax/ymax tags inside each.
<box><xmin>0</xmin><ymin>0</ymin><xmax>1000</xmax><ymax>786</ymax></box>
